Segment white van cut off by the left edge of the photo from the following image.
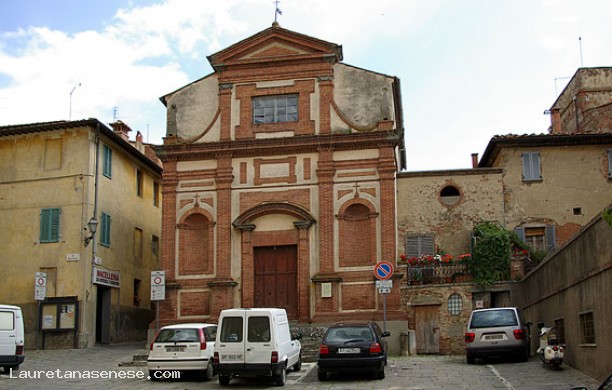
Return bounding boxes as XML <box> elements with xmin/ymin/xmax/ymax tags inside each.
<box><xmin>0</xmin><ymin>305</ymin><xmax>25</xmax><ymax>373</ymax></box>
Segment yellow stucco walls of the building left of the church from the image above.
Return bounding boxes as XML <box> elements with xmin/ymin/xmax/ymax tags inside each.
<box><xmin>0</xmin><ymin>127</ymin><xmax>161</xmax><ymax>348</ymax></box>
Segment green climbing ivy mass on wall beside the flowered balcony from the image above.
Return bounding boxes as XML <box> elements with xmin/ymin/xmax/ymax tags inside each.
<box><xmin>468</xmin><ymin>222</ymin><xmax>512</xmax><ymax>287</ymax></box>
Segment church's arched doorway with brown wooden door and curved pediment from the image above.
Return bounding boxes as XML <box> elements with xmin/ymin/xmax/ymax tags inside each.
<box><xmin>233</xmin><ymin>203</ymin><xmax>314</xmax><ymax>320</ymax></box>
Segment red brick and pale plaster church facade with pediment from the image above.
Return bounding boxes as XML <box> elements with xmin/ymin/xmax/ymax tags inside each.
<box><xmin>157</xmin><ymin>23</ymin><xmax>405</xmax><ymax>325</ymax></box>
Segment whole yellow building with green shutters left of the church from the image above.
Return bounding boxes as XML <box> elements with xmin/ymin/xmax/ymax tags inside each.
<box><xmin>0</xmin><ymin>119</ymin><xmax>161</xmax><ymax>349</ymax></box>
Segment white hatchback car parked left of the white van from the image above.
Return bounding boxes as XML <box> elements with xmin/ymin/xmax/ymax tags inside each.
<box><xmin>147</xmin><ymin>323</ymin><xmax>217</xmax><ymax>380</ymax></box>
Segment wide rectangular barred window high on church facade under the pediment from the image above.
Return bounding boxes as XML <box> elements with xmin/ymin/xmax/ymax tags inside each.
<box><xmin>252</xmin><ymin>94</ymin><xmax>298</xmax><ymax>124</ymax></box>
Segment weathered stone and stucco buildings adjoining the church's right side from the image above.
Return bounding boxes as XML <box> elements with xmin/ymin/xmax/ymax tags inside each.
<box><xmin>397</xmin><ymin>68</ymin><xmax>612</xmax><ymax>360</ymax></box>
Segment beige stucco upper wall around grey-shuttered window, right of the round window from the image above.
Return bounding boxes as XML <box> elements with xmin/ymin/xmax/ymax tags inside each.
<box><xmin>501</xmin><ymin>145</ymin><xmax>612</xmax><ymax>244</ymax></box>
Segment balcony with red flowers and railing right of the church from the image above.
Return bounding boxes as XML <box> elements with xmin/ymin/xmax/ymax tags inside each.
<box><xmin>399</xmin><ymin>253</ymin><xmax>471</xmax><ymax>285</ymax></box>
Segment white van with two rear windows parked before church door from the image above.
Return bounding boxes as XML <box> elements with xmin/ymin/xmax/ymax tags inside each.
<box><xmin>214</xmin><ymin>308</ymin><xmax>302</xmax><ymax>386</ymax></box>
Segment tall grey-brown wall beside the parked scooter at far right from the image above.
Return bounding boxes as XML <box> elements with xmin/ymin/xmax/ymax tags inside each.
<box><xmin>513</xmin><ymin>210</ymin><xmax>612</xmax><ymax>380</ymax></box>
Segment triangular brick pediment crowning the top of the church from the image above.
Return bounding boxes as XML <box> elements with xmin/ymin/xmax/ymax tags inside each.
<box><xmin>208</xmin><ymin>25</ymin><xmax>342</xmax><ymax>70</ymax></box>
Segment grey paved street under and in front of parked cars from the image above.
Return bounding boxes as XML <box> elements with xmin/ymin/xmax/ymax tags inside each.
<box><xmin>0</xmin><ymin>343</ymin><xmax>598</xmax><ymax>390</ymax></box>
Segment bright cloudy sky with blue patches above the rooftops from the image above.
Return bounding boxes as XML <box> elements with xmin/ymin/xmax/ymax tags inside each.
<box><xmin>0</xmin><ymin>0</ymin><xmax>612</xmax><ymax>171</ymax></box>
